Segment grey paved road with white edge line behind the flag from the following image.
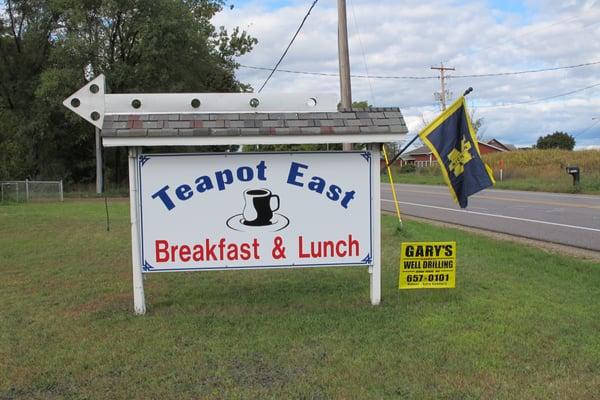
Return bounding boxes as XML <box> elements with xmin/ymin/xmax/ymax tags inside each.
<box><xmin>381</xmin><ymin>183</ymin><xmax>600</xmax><ymax>251</ymax></box>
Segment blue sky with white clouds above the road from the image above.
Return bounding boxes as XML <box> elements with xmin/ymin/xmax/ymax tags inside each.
<box><xmin>214</xmin><ymin>0</ymin><xmax>600</xmax><ymax>148</ymax></box>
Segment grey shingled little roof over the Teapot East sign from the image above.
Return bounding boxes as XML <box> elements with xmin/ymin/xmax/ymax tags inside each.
<box><xmin>102</xmin><ymin>107</ymin><xmax>408</xmax><ymax>146</ymax></box>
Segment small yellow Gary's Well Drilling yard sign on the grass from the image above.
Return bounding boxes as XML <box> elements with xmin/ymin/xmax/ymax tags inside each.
<box><xmin>398</xmin><ymin>242</ymin><xmax>456</xmax><ymax>289</ymax></box>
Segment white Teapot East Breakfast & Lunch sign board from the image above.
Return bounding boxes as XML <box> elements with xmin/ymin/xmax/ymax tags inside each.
<box><xmin>137</xmin><ymin>151</ymin><xmax>372</xmax><ymax>272</ymax></box>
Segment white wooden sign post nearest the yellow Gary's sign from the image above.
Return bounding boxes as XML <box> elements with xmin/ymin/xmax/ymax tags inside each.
<box><xmin>368</xmin><ymin>143</ymin><xmax>381</xmax><ymax>306</ymax></box>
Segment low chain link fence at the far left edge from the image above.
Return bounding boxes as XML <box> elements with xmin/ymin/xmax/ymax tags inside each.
<box><xmin>0</xmin><ymin>180</ymin><xmax>64</xmax><ymax>202</ymax></box>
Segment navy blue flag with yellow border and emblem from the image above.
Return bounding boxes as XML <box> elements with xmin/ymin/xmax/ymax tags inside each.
<box><xmin>419</xmin><ymin>96</ymin><xmax>495</xmax><ymax>208</ymax></box>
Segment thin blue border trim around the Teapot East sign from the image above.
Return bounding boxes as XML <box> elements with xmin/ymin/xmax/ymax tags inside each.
<box><xmin>137</xmin><ymin>150</ymin><xmax>373</xmax><ymax>273</ymax></box>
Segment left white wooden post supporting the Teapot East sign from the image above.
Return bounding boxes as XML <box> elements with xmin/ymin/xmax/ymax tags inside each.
<box><xmin>129</xmin><ymin>147</ymin><xmax>146</xmax><ymax>315</ymax></box>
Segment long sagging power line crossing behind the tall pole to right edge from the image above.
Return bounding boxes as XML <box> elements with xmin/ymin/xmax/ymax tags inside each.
<box><xmin>240</xmin><ymin>61</ymin><xmax>600</xmax><ymax>80</ymax></box>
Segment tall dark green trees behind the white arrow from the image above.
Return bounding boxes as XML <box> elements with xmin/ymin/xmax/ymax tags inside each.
<box><xmin>0</xmin><ymin>0</ymin><xmax>257</xmax><ymax>184</ymax></box>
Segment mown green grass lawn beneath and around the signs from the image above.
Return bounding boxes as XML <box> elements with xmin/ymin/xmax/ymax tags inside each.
<box><xmin>0</xmin><ymin>201</ymin><xmax>600</xmax><ymax>399</ymax></box>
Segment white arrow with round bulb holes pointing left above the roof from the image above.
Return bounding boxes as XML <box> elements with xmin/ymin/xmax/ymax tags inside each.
<box><xmin>63</xmin><ymin>75</ymin><xmax>338</xmax><ymax>129</ymax></box>
